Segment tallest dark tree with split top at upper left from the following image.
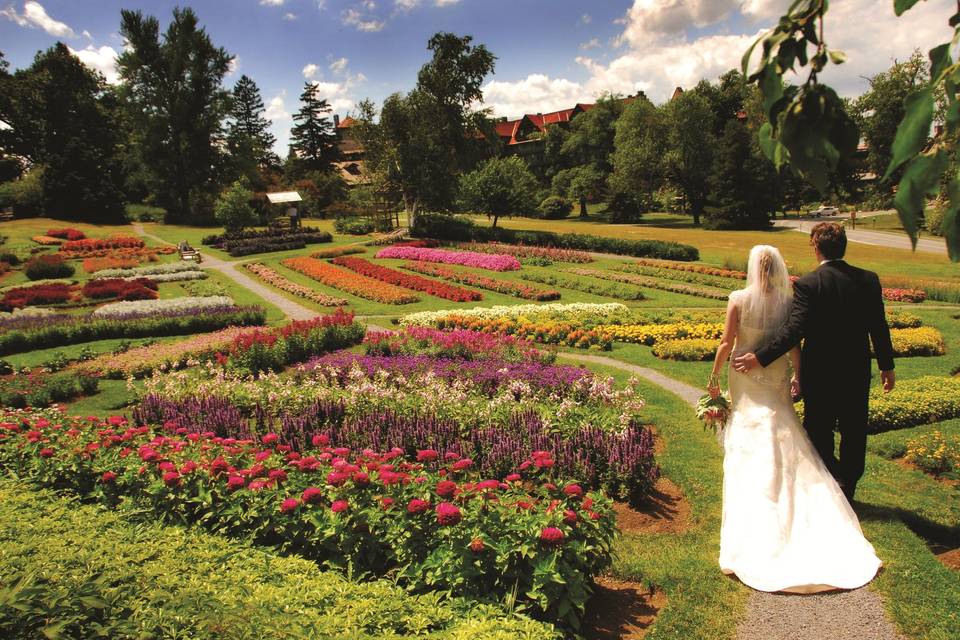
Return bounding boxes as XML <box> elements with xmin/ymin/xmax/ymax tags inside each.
<box><xmin>117</xmin><ymin>9</ymin><xmax>233</xmax><ymax>222</ymax></box>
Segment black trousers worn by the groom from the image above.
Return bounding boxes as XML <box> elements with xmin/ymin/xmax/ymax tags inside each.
<box><xmin>803</xmin><ymin>374</ymin><xmax>870</xmax><ymax>498</ymax></box>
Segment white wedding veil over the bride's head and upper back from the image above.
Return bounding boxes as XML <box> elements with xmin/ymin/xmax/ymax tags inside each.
<box><xmin>738</xmin><ymin>244</ymin><xmax>793</xmax><ymax>336</ymax></box>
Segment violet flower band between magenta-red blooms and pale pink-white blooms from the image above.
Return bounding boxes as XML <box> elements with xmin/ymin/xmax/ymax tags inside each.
<box><xmin>305</xmin><ymin>351</ymin><xmax>592</xmax><ymax>395</ymax></box>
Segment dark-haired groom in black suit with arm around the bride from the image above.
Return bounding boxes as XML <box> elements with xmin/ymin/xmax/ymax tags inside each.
<box><xmin>733</xmin><ymin>222</ymin><xmax>896</xmax><ymax>501</ymax></box>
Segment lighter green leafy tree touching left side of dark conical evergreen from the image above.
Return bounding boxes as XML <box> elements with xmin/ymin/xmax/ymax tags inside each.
<box><xmin>663</xmin><ymin>91</ymin><xmax>716</xmax><ymax>226</ymax></box>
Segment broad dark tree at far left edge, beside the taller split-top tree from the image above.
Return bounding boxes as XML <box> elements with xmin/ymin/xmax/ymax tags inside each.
<box><xmin>2</xmin><ymin>43</ymin><xmax>125</xmax><ymax>223</ymax></box>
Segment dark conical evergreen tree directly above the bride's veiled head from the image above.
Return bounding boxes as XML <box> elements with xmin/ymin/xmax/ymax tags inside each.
<box><xmin>705</xmin><ymin>120</ymin><xmax>774</xmax><ymax>229</ymax></box>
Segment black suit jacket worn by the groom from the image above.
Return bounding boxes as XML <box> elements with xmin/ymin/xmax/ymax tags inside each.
<box><xmin>756</xmin><ymin>260</ymin><xmax>893</xmax><ymax>396</ymax></box>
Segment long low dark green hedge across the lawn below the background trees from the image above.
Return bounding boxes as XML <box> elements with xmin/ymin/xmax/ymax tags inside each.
<box><xmin>410</xmin><ymin>213</ymin><xmax>700</xmax><ymax>262</ymax></box>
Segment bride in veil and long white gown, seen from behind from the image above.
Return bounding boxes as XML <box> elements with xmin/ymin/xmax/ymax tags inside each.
<box><xmin>708</xmin><ymin>245</ymin><xmax>881</xmax><ymax>593</ymax></box>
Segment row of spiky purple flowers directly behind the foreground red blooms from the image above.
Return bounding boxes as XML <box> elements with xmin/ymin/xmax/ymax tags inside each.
<box><xmin>133</xmin><ymin>395</ymin><xmax>660</xmax><ymax>505</ymax></box>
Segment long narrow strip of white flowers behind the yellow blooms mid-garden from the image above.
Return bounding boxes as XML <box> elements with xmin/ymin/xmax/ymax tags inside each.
<box><xmin>400</xmin><ymin>302</ymin><xmax>630</xmax><ymax>327</ymax></box>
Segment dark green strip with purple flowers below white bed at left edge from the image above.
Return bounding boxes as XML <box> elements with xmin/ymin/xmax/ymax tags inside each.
<box><xmin>0</xmin><ymin>303</ymin><xmax>266</xmax><ymax>355</ymax></box>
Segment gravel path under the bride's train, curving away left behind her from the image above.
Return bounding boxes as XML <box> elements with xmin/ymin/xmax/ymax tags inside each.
<box><xmin>559</xmin><ymin>353</ymin><xmax>903</xmax><ymax>640</ymax></box>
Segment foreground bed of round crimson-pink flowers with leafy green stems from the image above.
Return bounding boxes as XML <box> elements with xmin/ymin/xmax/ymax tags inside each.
<box><xmin>0</xmin><ymin>408</ymin><xmax>616</xmax><ymax>628</ymax></box>
